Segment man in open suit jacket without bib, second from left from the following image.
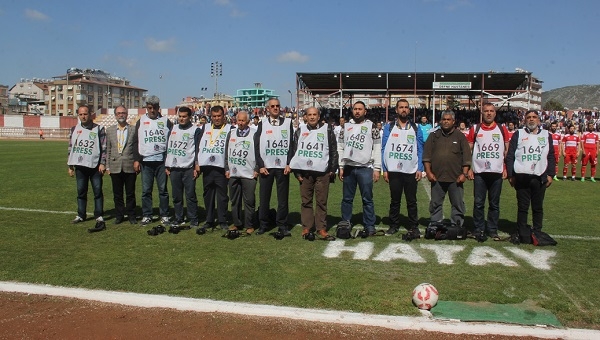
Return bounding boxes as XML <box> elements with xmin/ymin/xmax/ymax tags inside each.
<box><xmin>106</xmin><ymin>105</ymin><xmax>137</xmax><ymax>224</ymax></box>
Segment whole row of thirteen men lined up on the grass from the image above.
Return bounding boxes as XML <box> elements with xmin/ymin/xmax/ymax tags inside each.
<box><xmin>69</xmin><ymin>96</ymin><xmax>554</xmax><ymax>244</ymax></box>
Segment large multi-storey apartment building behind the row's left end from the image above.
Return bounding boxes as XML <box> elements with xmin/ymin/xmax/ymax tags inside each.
<box><xmin>45</xmin><ymin>68</ymin><xmax>147</xmax><ymax>116</ymax></box>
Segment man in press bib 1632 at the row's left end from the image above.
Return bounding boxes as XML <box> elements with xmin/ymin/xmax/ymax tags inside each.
<box><xmin>67</xmin><ymin>105</ymin><xmax>106</xmax><ymax>233</ymax></box>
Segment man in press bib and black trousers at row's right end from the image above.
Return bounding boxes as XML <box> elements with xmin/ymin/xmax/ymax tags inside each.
<box><xmin>506</xmin><ymin>110</ymin><xmax>555</xmax><ymax>244</ymax></box>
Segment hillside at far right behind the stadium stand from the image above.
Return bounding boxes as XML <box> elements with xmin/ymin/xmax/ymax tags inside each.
<box><xmin>542</xmin><ymin>85</ymin><xmax>600</xmax><ymax>110</ymax></box>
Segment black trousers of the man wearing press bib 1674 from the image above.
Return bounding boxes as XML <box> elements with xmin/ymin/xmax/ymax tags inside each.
<box><xmin>388</xmin><ymin>172</ymin><xmax>419</xmax><ymax>230</ymax></box>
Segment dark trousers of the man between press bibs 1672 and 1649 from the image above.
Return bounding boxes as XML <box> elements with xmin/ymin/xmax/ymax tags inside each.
<box><xmin>200</xmin><ymin>166</ymin><xmax>229</xmax><ymax>224</ymax></box>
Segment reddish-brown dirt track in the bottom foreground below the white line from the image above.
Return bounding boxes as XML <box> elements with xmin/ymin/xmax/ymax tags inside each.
<box><xmin>0</xmin><ymin>292</ymin><xmax>548</xmax><ymax>340</ymax></box>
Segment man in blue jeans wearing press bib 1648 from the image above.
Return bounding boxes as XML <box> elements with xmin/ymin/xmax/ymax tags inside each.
<box><xmin>338</xmin><ymin>101</ymin><xmax>381</xmax><ymax>236</ymax></box>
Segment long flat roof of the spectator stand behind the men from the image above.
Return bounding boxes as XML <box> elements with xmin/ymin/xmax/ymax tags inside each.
<box><xmin>296</xmin><ymin>72</ymin><xmax>531</xmax><ymax>96</ymax></box>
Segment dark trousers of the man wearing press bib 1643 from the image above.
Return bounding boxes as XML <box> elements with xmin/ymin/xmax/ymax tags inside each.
<box><xmin>258</xmin><ymin>169</ymin><xmax>290</xmax><ymax>229</ymax></box>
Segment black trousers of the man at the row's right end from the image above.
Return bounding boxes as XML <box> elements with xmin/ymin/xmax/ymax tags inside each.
<box><xmin>515</xmin><ymin>174</ymin><xmax>546</xmax><ymax>243</ymax></box>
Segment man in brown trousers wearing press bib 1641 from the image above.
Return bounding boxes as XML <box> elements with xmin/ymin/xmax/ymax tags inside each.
<box><xmin>290</xmin><ymin>107</ymin><xmax>338</xmax><ymax>241</ymax></box>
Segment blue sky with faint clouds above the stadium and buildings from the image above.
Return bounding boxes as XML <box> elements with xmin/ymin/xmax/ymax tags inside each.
<box><xmin>0</xmin><ymin>0</ymin><xmax>600</xmax><ymax>107</ymax></box>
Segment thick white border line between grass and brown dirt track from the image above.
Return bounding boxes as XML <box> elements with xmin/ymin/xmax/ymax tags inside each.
<box><xmin>0</xmin><ymin>282</ymin><xmax>600</xmax><ymax>339</ymax></box>
